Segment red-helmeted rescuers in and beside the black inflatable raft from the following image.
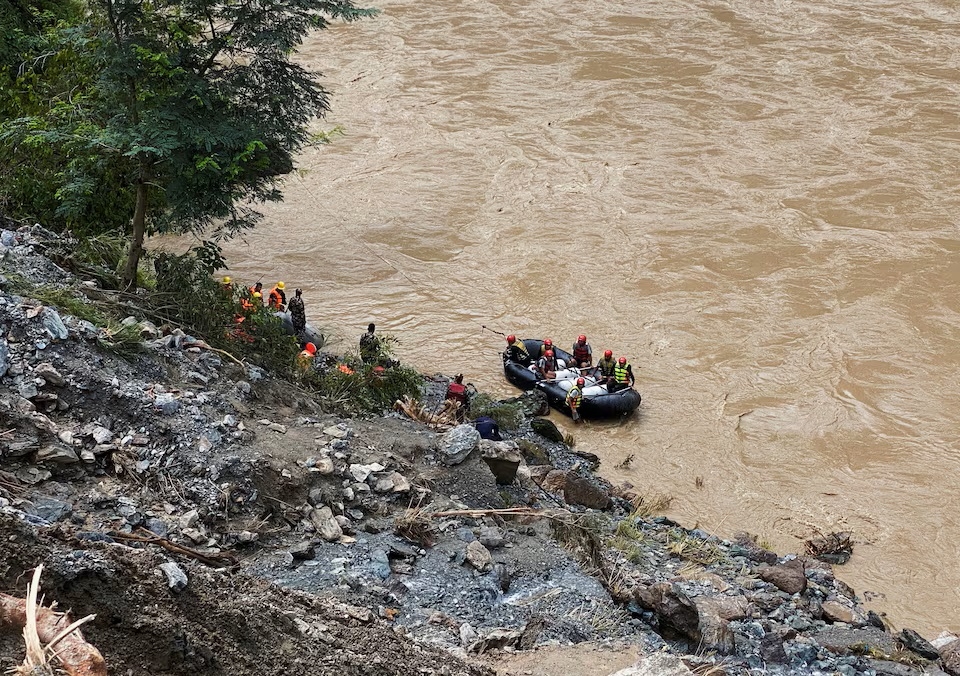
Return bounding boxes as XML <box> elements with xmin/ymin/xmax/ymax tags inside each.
<box><xmin>504</xmin><ymin>334</ymin><xmax>636</xmax><ymax>422</ymax></box>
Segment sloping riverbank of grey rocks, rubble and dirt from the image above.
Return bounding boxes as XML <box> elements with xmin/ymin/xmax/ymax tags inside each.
<box><xmin>0</xmin><ymin>224</ymin><xmax>960</xmax><ymax>676</ymax></box>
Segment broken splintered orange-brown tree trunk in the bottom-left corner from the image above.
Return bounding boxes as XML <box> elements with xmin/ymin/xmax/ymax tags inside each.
<box><xmin>0</xmin><ymin>571</ymin><xmax>107</xmax><ymax>676</ymax></box>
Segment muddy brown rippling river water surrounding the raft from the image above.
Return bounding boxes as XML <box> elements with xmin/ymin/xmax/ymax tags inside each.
<box><xmin>218</xmin><ymin>0</ymin><xmax>960</xmax><ymax>637</ymax></box>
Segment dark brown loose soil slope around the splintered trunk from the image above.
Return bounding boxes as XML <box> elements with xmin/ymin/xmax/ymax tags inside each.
<box><xmin>0</xmin><ymin>515</ymin><xmax>493</xmax><ymax>676</ymax></box>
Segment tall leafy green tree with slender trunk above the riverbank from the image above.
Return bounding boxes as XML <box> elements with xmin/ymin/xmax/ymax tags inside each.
<box><xmin>0</xmin><ymin>0</ymin><xmax>374</xmax><ymax>288</ymax></box>
